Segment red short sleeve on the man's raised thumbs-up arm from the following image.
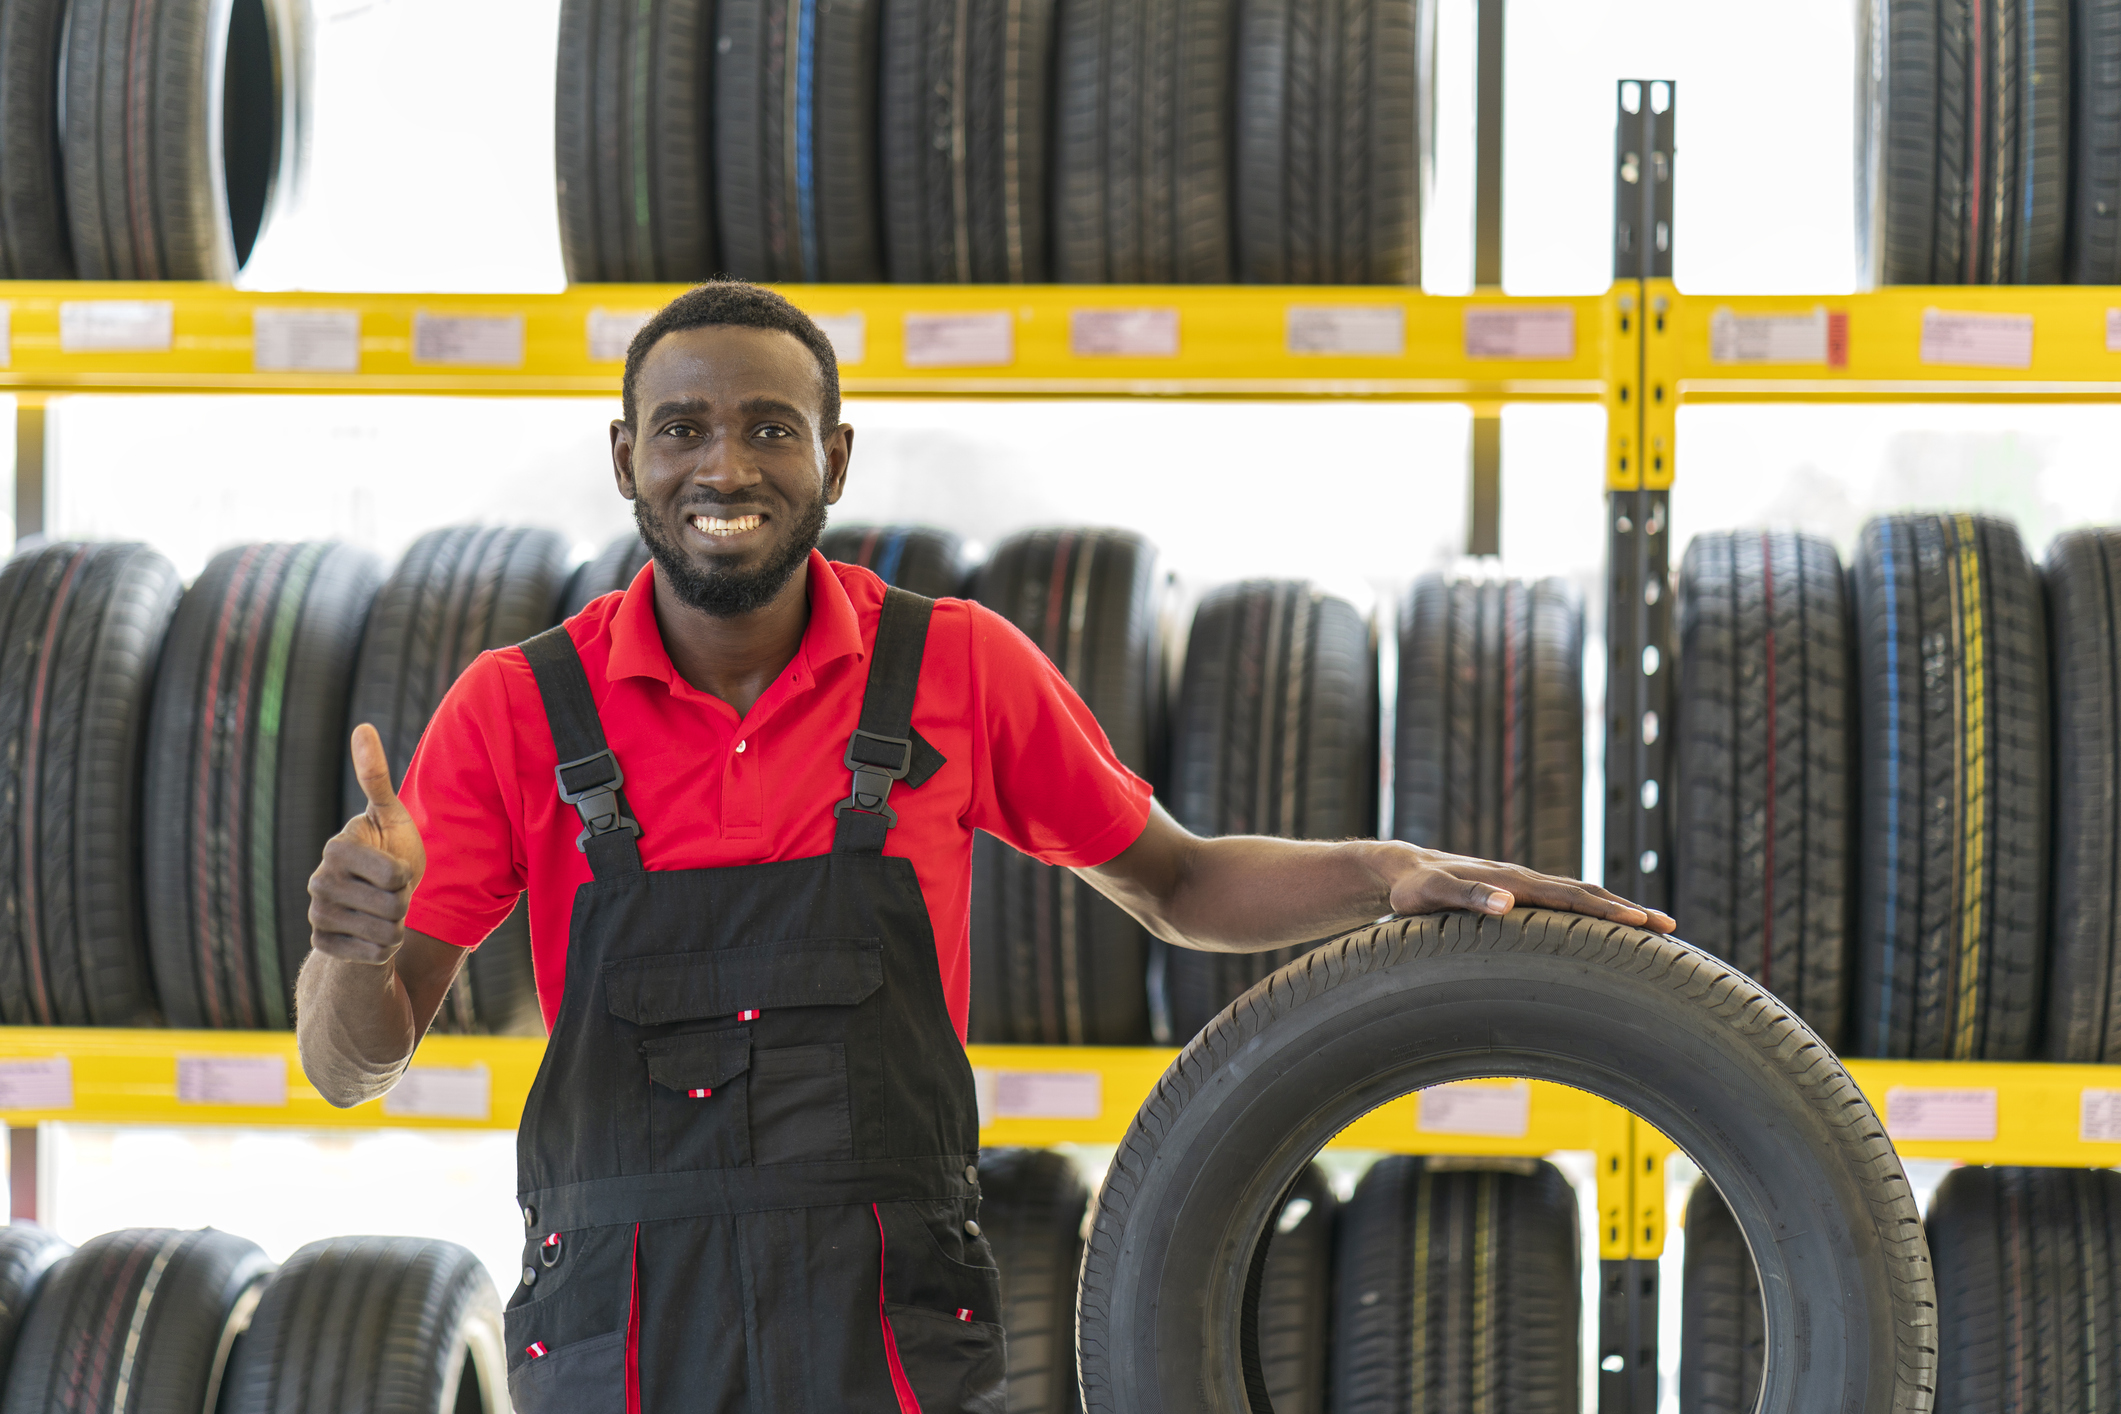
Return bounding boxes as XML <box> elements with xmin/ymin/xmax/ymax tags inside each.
<box><xmin>399</xmin><ymin>653</ymin><xmax>528</xmax><ymax>948</ymax></box>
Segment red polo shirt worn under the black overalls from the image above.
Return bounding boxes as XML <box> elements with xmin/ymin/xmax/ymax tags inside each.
<box><xmin>401</xmin><ymin>551</ymin><xmax>1150</xmax><ymax>1039</ymax></box>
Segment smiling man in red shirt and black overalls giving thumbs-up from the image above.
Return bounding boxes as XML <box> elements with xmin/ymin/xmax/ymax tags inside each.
<box><xmin>297</xmin><ymin>282</ymin><xmax>1671</xmax><ymax>1414</ymax></box>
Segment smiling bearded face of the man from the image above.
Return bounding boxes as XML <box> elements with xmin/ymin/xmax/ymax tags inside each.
<box><xmin>611</xmin><ymin>324</ymin><xmax>855</xmax><ymax>617</ymax></box>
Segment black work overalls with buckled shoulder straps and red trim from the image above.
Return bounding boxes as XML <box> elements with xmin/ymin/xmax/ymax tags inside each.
<box><xmin>507</xmin><ymin>589</ymin><xmax>1003</xmax><ymax>1414</ymax></box>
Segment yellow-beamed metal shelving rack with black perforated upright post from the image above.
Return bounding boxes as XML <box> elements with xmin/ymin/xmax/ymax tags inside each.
<box><xmin>0</xmin><ymin>81</ymin><xmax>2121</xmax><ymax>1414</ymax></box>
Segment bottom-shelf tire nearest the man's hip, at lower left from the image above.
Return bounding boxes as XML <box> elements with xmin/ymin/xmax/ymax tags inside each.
<box><xmin>221</xmin><ymin>1238</ymin><xmax>509</xmax><ymax>1414</ymax></box>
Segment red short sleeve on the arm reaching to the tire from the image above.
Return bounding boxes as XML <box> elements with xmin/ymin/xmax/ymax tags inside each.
<box><xmin>967</xmin><ymin>604</ymin><xmax>1152</xmax><ymax>867</ymax></box>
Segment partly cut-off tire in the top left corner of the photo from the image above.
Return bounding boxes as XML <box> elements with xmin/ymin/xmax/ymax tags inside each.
<box><xmin>0</xmin><ymin>0</ymin><xmax>74</xmax><ymax>280</ymax></box>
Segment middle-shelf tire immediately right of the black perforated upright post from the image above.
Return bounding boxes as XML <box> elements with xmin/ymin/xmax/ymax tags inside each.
<box><xmin>1673</xmin><ymin>530</ymin><xmax>1856</xmax><ymax>1045</ymax></box>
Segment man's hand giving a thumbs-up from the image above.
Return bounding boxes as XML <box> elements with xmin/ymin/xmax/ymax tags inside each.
<box><xmin>310</xmin><ymin>723</ymin><xmax>426</xmax><ymax>965</ymax></box>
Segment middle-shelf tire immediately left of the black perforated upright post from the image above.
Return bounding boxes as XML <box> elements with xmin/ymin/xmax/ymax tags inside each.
<box><xmin>1391</xmin><ymin>575</ymin><xmax>1584</xmax><ymax>878</ymax></box>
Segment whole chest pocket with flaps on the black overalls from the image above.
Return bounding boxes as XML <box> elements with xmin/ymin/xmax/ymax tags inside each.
<box><xmin>604</xmin><ymin>937</ymin><xmax>884</xmax><ymax>1172</ymax></box>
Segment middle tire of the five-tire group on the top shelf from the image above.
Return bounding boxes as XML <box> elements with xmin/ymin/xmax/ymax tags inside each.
<box><xmin>878</xmin><ymin>0</ymin><xmax>1054</xmax><ymax>284</ymax></box>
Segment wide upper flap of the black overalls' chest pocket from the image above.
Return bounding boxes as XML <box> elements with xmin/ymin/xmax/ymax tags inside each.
<box><xmin>604</xmin><ymin>937</ymin><xmax>884</xmax><ymax>1026</ymax></box>
